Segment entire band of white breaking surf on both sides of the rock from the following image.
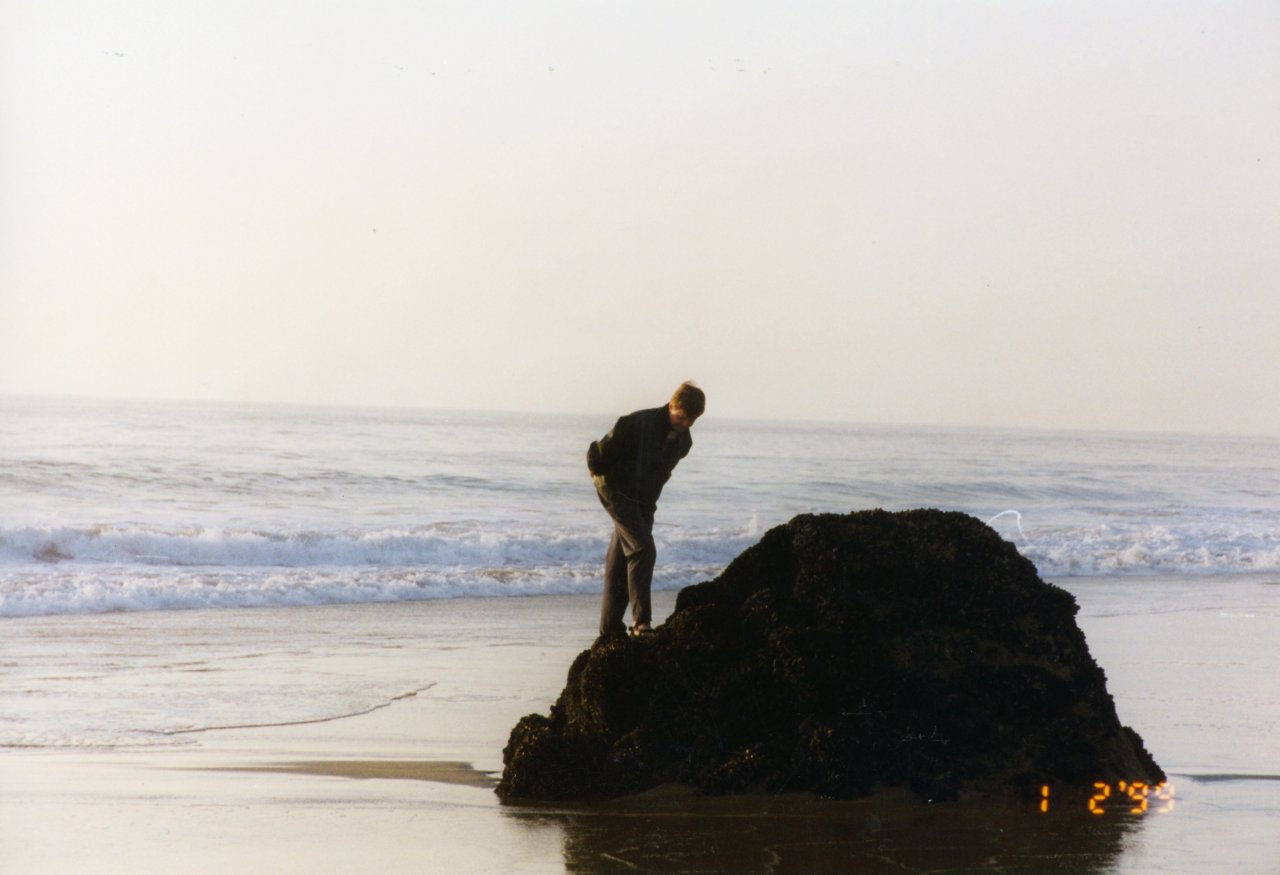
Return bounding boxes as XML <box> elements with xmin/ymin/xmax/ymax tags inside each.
<box><xmin>0</xmin><ymin>526</ymin><xmax>1280</xmax><ymax>617</ymax></box>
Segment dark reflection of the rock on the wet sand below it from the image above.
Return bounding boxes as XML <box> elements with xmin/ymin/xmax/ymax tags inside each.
<box><xmin>504</xmin><ymin>792</ymin><xmax>1142</xmax><ymax>875</ymax></box>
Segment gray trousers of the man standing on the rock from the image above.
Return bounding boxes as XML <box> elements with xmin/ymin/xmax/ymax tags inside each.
<box><xmin>596</xmin><ymin>491</ymin><xmax>658</xmax><ymax>635</ymax></box>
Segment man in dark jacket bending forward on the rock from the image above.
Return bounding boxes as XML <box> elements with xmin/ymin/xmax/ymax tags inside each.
<box><xmin>586</xmin><ymin>382</ymin><xmax>707</xmax><ymax>636</ymax></box>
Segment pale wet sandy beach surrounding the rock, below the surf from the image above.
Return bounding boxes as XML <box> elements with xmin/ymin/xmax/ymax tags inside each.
<box><xmin>0</xmin><ymin>576</ymin><xmax>1280</xmax><ymax>874</ymax></box>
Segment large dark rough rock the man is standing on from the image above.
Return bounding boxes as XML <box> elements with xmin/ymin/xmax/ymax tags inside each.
<box><xmin>498</xmin><ymin>510</ymin><xmax>1164</xmax><ymax>801</ymax></box>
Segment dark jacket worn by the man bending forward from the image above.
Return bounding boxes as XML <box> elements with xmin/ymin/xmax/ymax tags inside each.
<box><xmin>586</xmin><ymin>406</ymin><xmax>694</xmax><ymax>508</ymax></box>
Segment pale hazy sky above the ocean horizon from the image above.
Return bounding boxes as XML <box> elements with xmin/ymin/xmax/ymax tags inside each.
<box><xmin>0</xmin><ymin>0</ymin><xmax>1280</xmax><ymax>434</ymax></box>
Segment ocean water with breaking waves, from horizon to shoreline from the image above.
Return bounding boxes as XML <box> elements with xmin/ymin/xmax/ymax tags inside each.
<box><xmin>0</xmin><ymin>399</ymin><xmax>1280</xmax><ymax>618</ymax></box>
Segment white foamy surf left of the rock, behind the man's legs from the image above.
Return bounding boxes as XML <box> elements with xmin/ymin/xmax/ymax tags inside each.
<box><xmin>0</xmin><ymin>527</ymin><xmax>755</xmax><ymax>617</ymax></box>
